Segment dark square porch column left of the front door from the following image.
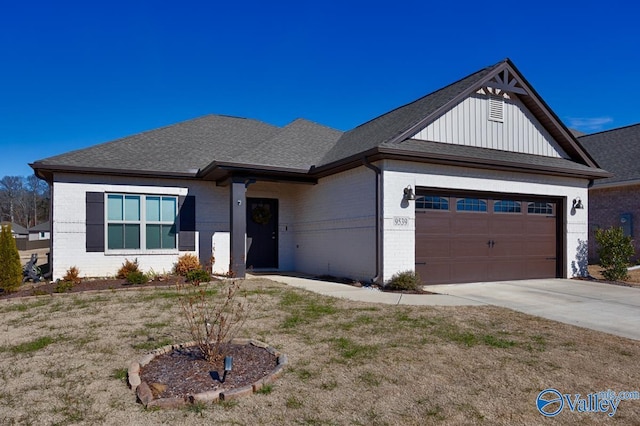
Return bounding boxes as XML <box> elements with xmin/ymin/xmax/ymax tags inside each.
<box><xmin>229</xmin><ymin>179</ymin><xmax>247</xmax><ymax>278</ymax></box>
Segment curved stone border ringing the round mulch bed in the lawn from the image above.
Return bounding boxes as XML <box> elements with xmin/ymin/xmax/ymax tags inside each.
<box><xmin>127</xmin><ymin>339</ymin><xmax>287</xmax><ymax>408</ymax></box>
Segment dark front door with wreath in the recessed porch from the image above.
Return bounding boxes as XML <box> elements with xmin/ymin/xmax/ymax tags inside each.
<box><xmin>247</xmin><ymin>198</ymin><xmax>278</xmax><ymax>269</ymax></box>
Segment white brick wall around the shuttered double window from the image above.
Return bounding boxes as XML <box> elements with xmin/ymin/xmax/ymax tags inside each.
<box><xmin>52</xmin><ymin>174</ymin><xmax>229</xmax><ymax>279</ymax></box>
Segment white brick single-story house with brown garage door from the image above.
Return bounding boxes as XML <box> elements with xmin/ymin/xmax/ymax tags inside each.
<box><xmin>31</xmin><ymin>59</ymin><xmax>610</xmax><ymax>283</ymax></box>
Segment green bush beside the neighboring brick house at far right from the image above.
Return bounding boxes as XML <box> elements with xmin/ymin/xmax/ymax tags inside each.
<box><xmin>596</xmin><ymin>227</ymin><xmax>635</xmax><ymax>281</ymax></box>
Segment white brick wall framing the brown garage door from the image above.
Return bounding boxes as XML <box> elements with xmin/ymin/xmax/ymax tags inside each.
<box><xmin>380</xmin><ymin>160</ymin><xmax>588</xmax><ymax>280</ymax></box>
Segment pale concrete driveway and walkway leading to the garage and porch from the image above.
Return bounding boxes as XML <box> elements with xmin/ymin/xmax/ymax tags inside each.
<box><xmin>252</xmin><ymin>274</ymin><xmax>640</xmax><ymax>340</ymax></box>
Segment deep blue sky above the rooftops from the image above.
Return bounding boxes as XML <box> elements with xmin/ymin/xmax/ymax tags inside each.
<box><xmin>0</xmin><ymin>0</ymin><xmax>640</xmax><ymax>177</ymax></box>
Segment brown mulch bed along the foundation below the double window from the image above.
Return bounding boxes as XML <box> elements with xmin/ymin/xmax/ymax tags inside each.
<box><xmin>0</xmin><ymin>276</ymin><xmax>185</xmax><ymax>299</ymax></box>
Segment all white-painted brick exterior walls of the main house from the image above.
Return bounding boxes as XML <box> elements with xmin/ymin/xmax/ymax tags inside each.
<box><xmin>52</xmin><ymin>160</ymin><xmax>588</xmax><ymax>282</ymax></box>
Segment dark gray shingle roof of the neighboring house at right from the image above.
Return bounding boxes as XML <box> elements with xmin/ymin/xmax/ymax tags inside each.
<box><xmin>578</xmin><ymin>123</ymin><xmax>640</xmax><ymax>186</ymax></box>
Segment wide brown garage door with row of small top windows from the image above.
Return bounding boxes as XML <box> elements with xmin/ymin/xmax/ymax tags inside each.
<box><xmin>416</xmin><ymin>194</ymin><xmax>558</xmax><ymax>284</ymax></box>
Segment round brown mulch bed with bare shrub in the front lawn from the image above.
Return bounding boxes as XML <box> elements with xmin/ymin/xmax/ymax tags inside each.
<box><xmin>140</xmin><ymin>344</ymin><xmax>278</xmax><ymax>398</ymax></box>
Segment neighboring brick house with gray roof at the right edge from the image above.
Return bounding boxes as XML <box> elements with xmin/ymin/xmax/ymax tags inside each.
<box><xmin>578</xmin><ymin>124</ymin><xmax>640</xmax><ymax>263</ymax></box>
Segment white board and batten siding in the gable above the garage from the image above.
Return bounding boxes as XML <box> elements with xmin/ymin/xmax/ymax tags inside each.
<box><xmin>413</xmin><ymin>94</ymin><xmax>570</xmax><ymax>158</ymax></box>
